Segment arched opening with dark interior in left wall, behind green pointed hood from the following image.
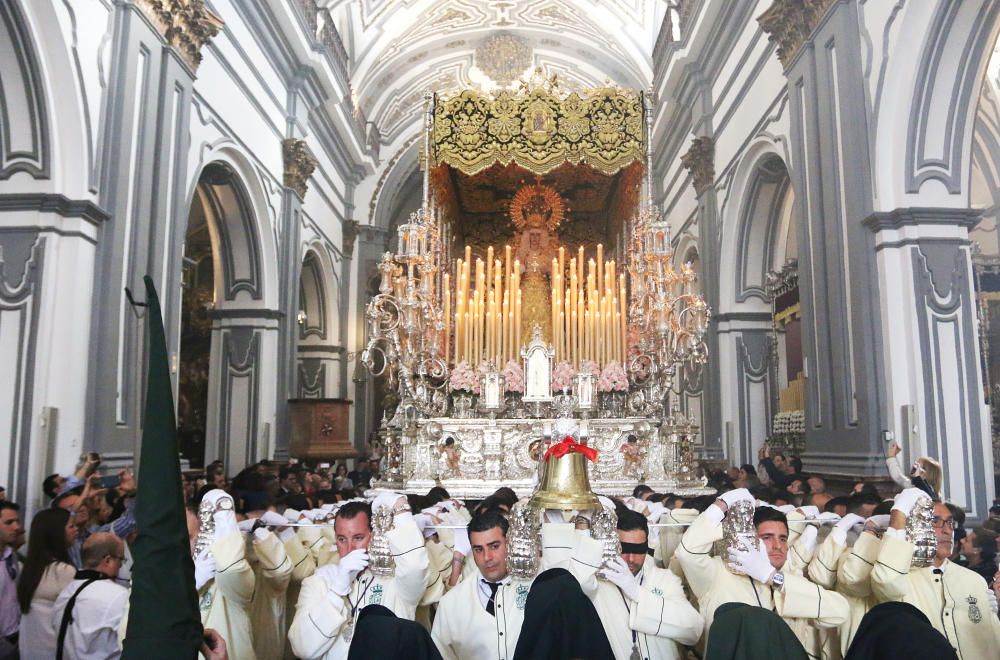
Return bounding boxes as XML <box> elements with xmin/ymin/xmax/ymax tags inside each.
<box><xmin>177</xmin><ymin>160</ymin><xmax>270</xmax><ymax>473</ymax></box>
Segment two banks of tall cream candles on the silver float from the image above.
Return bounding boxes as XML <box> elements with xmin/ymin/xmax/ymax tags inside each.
<box><xmin>443</xmin><ymin>245</ymin><xmax>628</xmax><ymax>369</ymax></box>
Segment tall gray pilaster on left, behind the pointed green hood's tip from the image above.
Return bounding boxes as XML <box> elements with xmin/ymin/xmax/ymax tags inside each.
<box><xmin>84</xmin><ymin>2</ymin><xmax>201</xmax><ymax>462</ymax></box>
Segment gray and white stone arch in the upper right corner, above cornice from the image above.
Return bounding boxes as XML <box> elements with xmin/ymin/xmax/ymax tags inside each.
<box><xmin>873</xmin><ymin>0</ymin><xmax>1000</xmax><ymax>211</ymax></box>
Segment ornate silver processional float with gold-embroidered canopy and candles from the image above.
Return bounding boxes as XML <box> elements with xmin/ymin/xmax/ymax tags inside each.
<box><xmin>362</xmin><ymin>73</ymin><xmax>710</xmax><ymax>498</ymax></box>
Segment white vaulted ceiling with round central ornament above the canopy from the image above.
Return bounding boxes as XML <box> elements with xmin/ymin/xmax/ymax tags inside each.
<box><xmin>319</xmin><ymin>0</ymin><xmax>666</xmax><ymax>144</ymax></box>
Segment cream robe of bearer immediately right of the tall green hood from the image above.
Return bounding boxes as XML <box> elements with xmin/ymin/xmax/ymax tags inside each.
<box><xmin>199</xmin><ymin>532</ymin><xmax>257</xmax><ymax>660</ymax></box>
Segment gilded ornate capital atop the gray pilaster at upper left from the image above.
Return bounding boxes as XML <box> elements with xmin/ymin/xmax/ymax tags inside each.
<box><xmin>135</xmin><ymin>0</ymin><xmax>224</xmax><ymax>71</ymax></box>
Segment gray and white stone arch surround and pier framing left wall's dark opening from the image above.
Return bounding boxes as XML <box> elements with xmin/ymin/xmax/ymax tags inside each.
<box><xmin>178</xmin><ymin>147</ymin><xmax>280</xmax><ymax>472</ymax></box>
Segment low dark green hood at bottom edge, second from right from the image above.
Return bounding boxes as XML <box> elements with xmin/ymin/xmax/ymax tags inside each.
<box><xmin>705</xmin><ymin>603</ymin><xmax>809</xmax><ymax>660</ymax></box>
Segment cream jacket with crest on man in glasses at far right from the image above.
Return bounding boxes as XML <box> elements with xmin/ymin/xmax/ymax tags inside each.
<box><xmin>871</xmin><ymin>530</ymin><xmax>1000</xmax><ymax>660</ymax></box>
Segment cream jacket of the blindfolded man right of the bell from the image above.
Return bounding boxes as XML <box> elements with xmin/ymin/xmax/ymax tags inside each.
<box><xmin>581</xmin><ymin>557</ymin><xmax>705</xmax><ymax>660</ymax></box>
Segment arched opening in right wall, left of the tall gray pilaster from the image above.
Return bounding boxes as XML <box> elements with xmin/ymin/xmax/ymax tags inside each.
<box><xmin>717</xmin><ymin>147</ymin><xmax>805</xmax><ymax>463</ymax></box>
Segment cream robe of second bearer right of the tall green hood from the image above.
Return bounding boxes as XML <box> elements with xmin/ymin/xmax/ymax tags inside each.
<box><xmin>250</xmin><ymin>528</ymin><xmax>292</xmax><ymax>660</ymax></box>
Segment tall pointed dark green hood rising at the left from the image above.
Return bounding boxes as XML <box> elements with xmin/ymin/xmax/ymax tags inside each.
<box><xmin>122</xmin><ymin>275</ymin><xmax>202</xmax><ymax>660</ymax></box>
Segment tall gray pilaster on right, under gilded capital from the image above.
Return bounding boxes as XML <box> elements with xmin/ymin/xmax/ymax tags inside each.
<box><xmin>785</xmin><ymin>2</ymin><xmax>885</xmax><ymax>474</ymax></box>
